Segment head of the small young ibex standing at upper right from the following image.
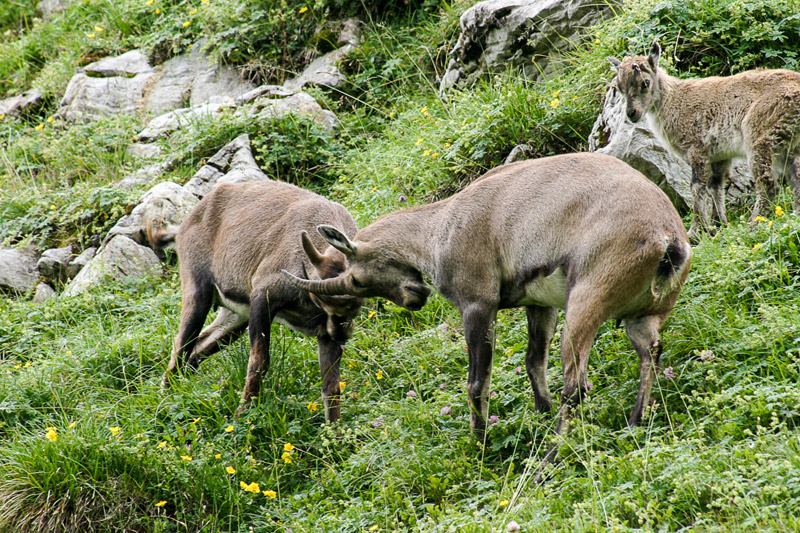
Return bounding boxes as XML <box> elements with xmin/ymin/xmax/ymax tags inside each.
<box><xmin>608</xmin><ymin>43</ymin><xmax>661</xmax><ymax>123</ymax></box>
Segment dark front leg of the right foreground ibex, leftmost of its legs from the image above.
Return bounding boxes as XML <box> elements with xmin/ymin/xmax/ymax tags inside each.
<box><xmin>461</xmin><ymin>304</ymin><xmax>497</xmax><ymax>441</ymax></box>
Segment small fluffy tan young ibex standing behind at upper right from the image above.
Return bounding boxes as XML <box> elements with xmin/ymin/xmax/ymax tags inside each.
<box><xmin>609</xmin><ymin>43</ymin><xmax>800</xmax><ymax>237</ymax></box>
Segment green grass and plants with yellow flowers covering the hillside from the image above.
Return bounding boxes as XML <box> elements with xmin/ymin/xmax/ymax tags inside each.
<box><xmin>0</xmin><ymin>0</ymin><xmax>800</xmax><ymax>532</ymax></box>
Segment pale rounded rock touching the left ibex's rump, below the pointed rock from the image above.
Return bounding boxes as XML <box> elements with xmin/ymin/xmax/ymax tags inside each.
<box><xmin>104</xmin><ymin>181</ymin><xmax>199</xmax><ymax>245</ymax></box>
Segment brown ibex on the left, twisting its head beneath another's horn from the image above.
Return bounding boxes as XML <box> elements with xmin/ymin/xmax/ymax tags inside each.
<box><xmin>157</xmin><ymin>181</ymin><xmax>363</xmax><ymax>421</ymax></box>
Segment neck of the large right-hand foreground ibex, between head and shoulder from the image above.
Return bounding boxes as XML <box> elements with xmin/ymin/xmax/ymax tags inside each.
<box><xmin>356</xmin><ymin>200</ymin><xmax>447</xmax><ymax>277</ymax></box>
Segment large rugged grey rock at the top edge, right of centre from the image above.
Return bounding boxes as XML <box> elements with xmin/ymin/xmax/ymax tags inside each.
<box><xmin>439</xmin><ymin>0</ymin><xmax>612</xmax><ymax>93</ymax></box>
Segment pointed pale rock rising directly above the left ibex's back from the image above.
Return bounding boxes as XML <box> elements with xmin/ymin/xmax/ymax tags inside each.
<box><xmin>183</xmin><ymin>134</ymin><xmax>269</xmax><ymax>198</ymax></box>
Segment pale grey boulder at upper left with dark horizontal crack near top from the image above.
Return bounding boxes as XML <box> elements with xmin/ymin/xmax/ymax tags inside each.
<box><xmin>58</xmin><ymin>50</ymin><xmax>155</xmax><ymax>122</ymax></box>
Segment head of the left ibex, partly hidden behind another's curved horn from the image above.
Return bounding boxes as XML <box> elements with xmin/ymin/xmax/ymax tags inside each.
<box><xmin>298</xmin><ymin>231</ymin><xmax>364</xmax><ymax>343</ymax></box>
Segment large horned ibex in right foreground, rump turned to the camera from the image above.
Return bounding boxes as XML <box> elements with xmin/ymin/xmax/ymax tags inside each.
<box><xmin>284</xmin><ymin>153</ymin><xmax>692</xmax><ymax>437</ymax></box>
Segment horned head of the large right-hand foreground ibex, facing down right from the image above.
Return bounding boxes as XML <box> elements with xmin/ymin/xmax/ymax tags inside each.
<box><xmin>283</xmin><ymin>225</ymin><xmax>431</xmax><ymax>311</ymax></box>
